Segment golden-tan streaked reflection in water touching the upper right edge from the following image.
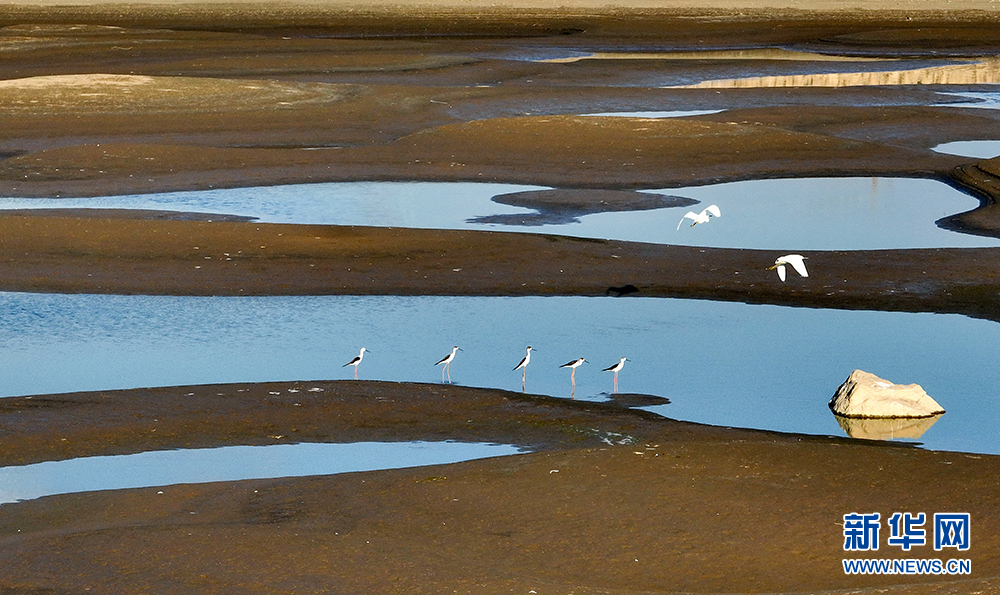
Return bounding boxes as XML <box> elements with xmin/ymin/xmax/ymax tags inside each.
<box><xmin>670</xmin><ymin>57</ymin><xmax>1000</xmax><ymax>89</ymax></box>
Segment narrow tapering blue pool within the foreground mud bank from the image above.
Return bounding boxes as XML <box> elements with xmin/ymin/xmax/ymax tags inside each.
<box><xmin>0</xmin><ymin>442</ymin><xmax>523</xmax><ymax>504</ymax></box>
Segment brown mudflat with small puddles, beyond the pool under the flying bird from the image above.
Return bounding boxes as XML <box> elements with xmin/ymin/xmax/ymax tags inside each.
<box><xmin>0</xmin><ymin>12</ymin><xmax>1000</xmax><ymax>203</ymax></box>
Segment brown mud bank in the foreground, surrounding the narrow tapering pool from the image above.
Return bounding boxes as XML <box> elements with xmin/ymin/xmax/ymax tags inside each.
<box><xmin>0</xmin><ymin>381</ymin><xmax>1000</xmax><ymax>593</ymax></box>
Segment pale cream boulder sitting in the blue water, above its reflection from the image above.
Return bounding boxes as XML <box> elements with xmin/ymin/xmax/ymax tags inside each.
<box><xmin>830</xmin><ymin>370</ymin><xmax>944</xmax><ymax>417</ymax></box>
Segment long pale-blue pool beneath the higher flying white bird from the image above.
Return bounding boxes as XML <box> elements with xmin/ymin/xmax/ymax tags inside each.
<box><xmin>0</xmin><ymin>178</ymin><xmax>1000</xmax><ymax>250</ymax></box>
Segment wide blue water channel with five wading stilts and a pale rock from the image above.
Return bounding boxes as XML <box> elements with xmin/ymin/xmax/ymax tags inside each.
<box><xmin>0</xmin><ymin>293</ymin><xmax>1000</xmax><ymax>454</ymax></box>
